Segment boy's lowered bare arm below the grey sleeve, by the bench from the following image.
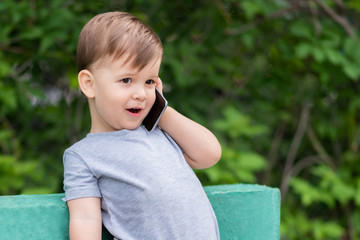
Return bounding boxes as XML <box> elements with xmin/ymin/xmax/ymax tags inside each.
<box><xmin>67</xmin><ymin>198</ymin><xmax>102</xmax><ymax>240</ymax></box>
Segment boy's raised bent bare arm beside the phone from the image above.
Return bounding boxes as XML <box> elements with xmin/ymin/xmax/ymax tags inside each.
<box><xmin>159</xmin><ymin>107</ymin><xmax>221</xmax><ymax>169</ymax></box>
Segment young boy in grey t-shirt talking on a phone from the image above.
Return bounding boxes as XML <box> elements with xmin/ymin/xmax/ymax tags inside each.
<box><xmin>64</xmin><ymin>12</ymin><xmax>221</xmax><ymax>240</ymax></box>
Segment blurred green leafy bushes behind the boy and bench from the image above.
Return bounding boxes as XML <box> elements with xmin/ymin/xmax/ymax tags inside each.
<box><xmin>0</xmin><ymin>0</ymin><xmax>360</xmax><ymax>240</ymax></box>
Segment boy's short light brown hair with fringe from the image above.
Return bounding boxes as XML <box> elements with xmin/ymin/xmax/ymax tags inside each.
<box><xmin>77</xmin><ymin>12</ymin><xmax>163</xmax><ymax>71</ymax></box>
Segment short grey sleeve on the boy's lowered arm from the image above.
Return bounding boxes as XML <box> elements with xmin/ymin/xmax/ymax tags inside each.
<box><xmin>63</xmin><ymin>150</ymin><xmax>101</xmax><ymax>201</ymax></box>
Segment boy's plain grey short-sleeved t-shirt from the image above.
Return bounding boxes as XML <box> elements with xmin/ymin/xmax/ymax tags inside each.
<box><xmin>64</xmin><ymin>127</ymin><xmax>220</xmax><ymax>240</ymax></box>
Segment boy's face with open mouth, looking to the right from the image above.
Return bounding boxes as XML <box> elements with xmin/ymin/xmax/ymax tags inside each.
<box><xmin>87</xmin><ymin>56</ymin><xmax>161</xmax><ymax>132</ymax></box>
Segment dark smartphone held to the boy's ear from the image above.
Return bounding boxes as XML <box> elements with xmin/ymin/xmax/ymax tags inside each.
<box><xmin>142</xmin><ymin>88</ymin><xmax>168</xmax><ymax>131</ymax></box>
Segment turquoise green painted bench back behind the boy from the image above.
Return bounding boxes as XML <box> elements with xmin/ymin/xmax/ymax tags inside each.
<box><xmin>0</xmin><ymin>184</ymin><xmax>280</xmax><ymax>240</ymax></box>
